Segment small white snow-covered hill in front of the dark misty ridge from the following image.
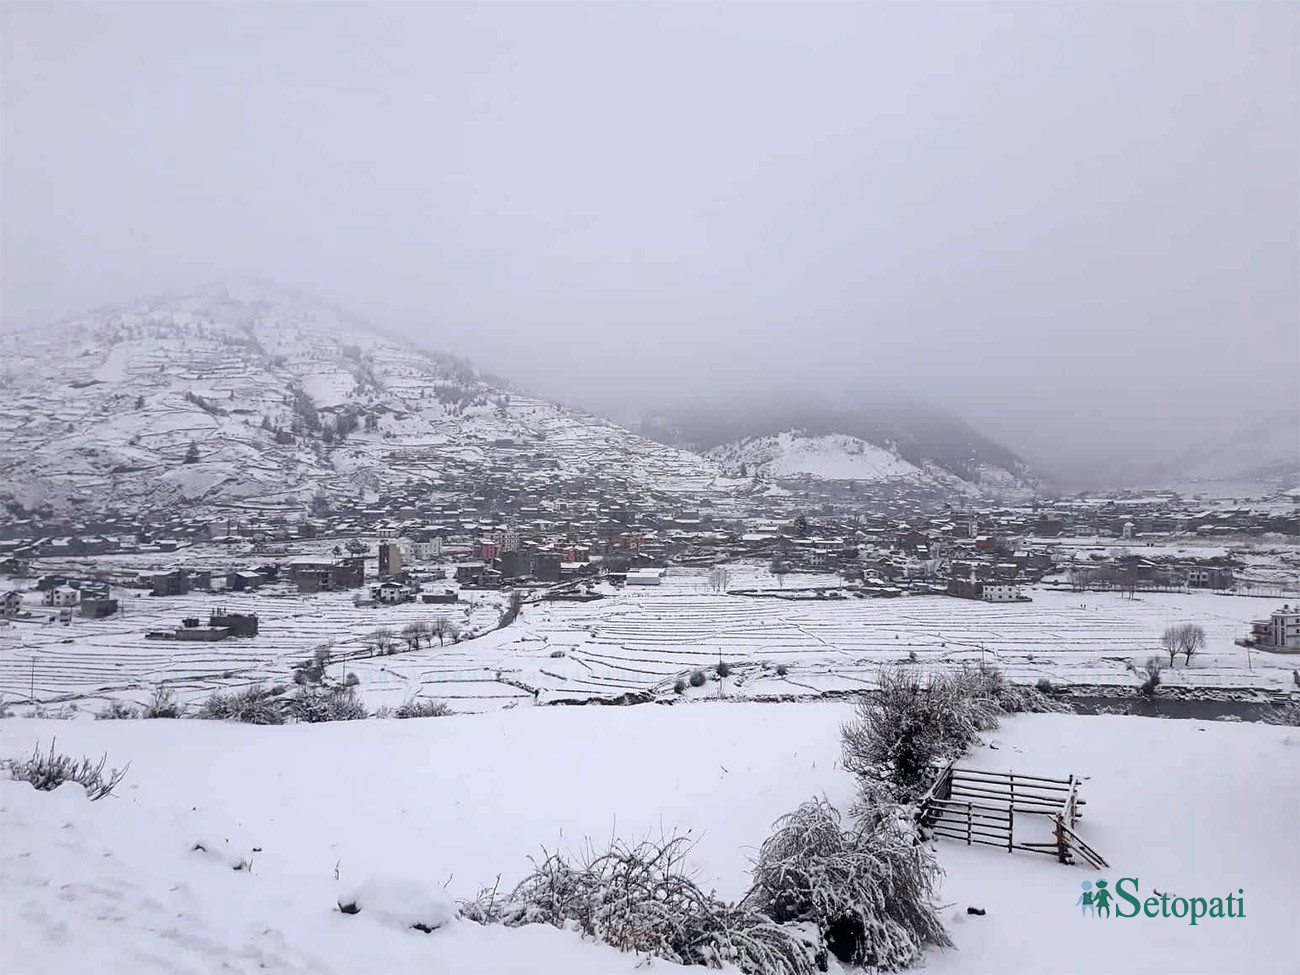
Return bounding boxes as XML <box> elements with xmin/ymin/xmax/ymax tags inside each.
<box><xmin>705</xmin><ymin>430</ymin><xmax>1036</xmax><ymax>495</ymax></box>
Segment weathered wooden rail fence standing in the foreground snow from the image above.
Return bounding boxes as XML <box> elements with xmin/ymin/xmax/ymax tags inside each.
<box><xmin>917</xmin><ymin>763</ymin><xmax>1108</xmax><ymax>868</ymax></box>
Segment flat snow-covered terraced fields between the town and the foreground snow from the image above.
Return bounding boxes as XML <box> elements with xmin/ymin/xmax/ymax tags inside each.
<box><xmin>0</xmin><ymin>567</ymin><xmax>1300</xmax><ymax>711</ymax></box>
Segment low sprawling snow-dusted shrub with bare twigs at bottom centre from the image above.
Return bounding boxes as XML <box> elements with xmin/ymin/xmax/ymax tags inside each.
<box><xmin>460</xmin><ymin>837</ymin><xmax>818</xmax><ymax>975</ymax></box>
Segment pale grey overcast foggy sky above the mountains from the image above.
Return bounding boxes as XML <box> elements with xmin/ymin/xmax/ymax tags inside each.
<box><xmin>0</xmin><ymin>0</ymin><xmax>1300</xmax><ymax>483</ymax></box>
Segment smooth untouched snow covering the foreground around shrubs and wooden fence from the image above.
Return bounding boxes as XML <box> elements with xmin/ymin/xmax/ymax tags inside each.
<box><xmin>0</xmin><ymin>703</ymin><xmax>1300</xmax><ymax>972</ymax></box>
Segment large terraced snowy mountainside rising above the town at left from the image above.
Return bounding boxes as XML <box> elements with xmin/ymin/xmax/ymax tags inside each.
<box><xmin>0</xmin><ymin>287</ymin><xmax>716</xmax><ymax>520</ymax></box>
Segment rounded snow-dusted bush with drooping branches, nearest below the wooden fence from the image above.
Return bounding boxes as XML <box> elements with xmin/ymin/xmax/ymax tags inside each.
<box><xmin>745</xmin><ymin>800</ymin><xmax>952</xmax><ymax>971</ymax></box>
